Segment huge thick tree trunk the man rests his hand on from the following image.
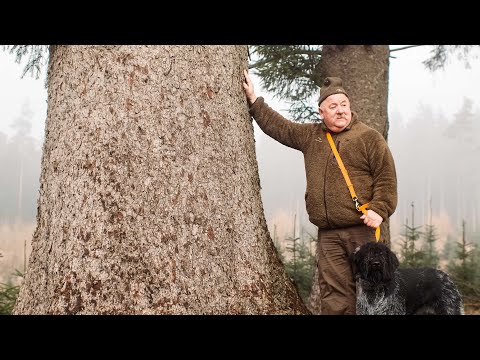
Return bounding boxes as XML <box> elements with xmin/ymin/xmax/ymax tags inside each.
<box><xmin>13</xmin><ymin>46</ymin><xmax>308</xmax><ymax>314</ymax></box>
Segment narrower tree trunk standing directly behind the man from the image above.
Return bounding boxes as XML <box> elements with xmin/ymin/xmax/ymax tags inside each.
<box><xmin>307</xmin><ymin>45</ymin><xmax>390</xmax><ymax>314</ymax></box>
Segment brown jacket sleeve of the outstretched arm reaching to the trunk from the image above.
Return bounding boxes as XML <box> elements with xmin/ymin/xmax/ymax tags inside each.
<box><xmin>249</xmin><ymin>96</ymin><xmax>311</xmax><ymax>150</ymax></box>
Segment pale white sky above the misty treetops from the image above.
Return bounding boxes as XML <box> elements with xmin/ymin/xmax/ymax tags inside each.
<box><xmin>0</xmin><ymin>45</ymin><xmax>480</xmax><ymax>141</ymax></box>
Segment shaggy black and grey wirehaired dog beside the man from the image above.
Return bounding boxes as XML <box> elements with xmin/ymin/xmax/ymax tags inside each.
<box><xmin>351</xmin><ymin>242</ymin><xmax>464</xmax><ymax>315</ymax></box>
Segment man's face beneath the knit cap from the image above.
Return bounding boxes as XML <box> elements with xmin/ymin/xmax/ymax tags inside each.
<box><xmin>318</xmin><ymin>94</ymin><xmax>352</xmax><ymax>133</ymax></box>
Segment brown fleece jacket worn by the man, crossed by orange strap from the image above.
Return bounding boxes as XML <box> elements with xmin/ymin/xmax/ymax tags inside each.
<box><xmin>250</xmin><ymin>97</ymin><xmax>397</xmax><ymax>229</ymax></box>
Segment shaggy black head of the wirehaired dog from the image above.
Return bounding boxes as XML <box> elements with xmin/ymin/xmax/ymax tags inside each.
<box><xmin>350</xmin><ymin>242</ymin><xmax>399</xmax><ymax>283</ymax></box>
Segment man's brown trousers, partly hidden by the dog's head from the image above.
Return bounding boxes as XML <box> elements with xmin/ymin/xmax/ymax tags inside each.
<box><xmin>317</xmin><ymin>225</ymin><xmax>376</xmax><ymax>315</ymax></box>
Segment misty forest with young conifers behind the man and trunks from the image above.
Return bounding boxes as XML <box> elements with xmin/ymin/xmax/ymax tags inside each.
<box><xmin>0</xmin><ymin>46</ymin><xmax>480</xmax><ymax>314</ymax></box>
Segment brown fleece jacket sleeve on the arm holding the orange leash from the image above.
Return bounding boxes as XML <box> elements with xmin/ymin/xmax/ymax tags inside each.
<box><xmin>368</xmin><ymin>134</ymin><xmax>398</xmax><ymax>220</ymax></box>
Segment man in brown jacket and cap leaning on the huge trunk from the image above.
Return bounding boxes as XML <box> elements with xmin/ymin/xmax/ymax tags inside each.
<box><xmin>243</xmin><ymin>70</ymin><xmax>397</xmax><ymax>315</ymax></box>
